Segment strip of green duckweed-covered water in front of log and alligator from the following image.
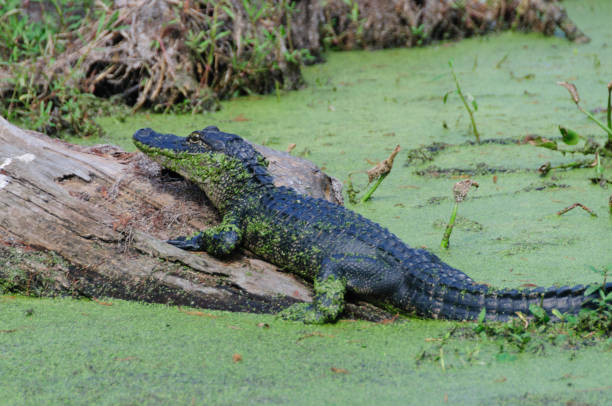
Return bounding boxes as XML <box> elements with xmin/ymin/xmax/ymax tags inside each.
<box><xmin>0</xmin><ymin>296</ymin><xmax>612</xmax><ymax>405</ymax></box>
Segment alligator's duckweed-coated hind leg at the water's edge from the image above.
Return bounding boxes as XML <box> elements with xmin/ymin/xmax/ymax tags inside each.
<box><xmin>279</xmin><ymin>275</ymin><xmax>346</xmax><ymax>324</ymax></box>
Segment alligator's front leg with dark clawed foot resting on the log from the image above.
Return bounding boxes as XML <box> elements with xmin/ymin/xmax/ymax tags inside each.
<box><xmin>167</xmin><ymin>214</ymin><xmax>242</xmax><ymax>257</ymax></box>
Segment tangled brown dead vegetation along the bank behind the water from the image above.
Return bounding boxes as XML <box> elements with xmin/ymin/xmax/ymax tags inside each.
<box><xmin>0</xmin><ymin>0</ymin><xmax>588</xmax><ymax>117</ymax></box>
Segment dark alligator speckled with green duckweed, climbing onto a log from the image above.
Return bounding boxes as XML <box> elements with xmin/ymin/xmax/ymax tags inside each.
<box><xmin>133</xmin><ymin>126</ymin><xmax>612</xmax><ymax>323</ymax></box>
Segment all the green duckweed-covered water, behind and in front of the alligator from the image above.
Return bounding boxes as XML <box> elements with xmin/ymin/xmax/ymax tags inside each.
<box><xmin>5</xmin><ymin>0</ymin><xmax>612</xmax><ymax>404</ymax></box>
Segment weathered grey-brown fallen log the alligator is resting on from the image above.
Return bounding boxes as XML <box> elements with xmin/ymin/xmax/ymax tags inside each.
<box><xmin>0</xmin><ymin>117</ymin><xmax>388</xmax><ymax>319</ymax></box>
